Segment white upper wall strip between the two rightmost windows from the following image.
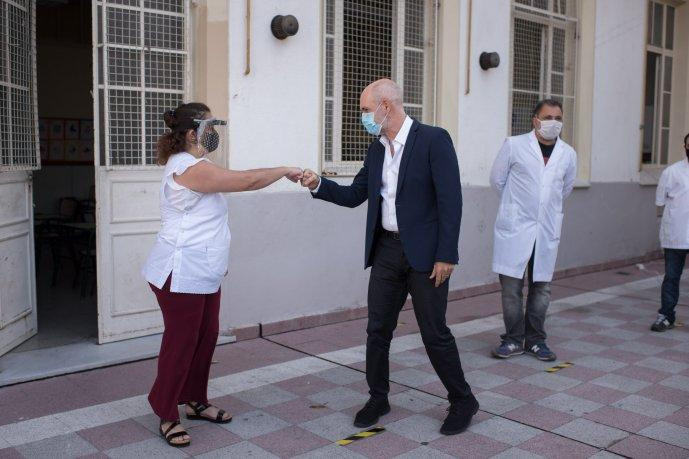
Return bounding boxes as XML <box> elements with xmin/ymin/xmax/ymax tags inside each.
<box><xmin>591</xmin><ymin>0</ymin><xmax>647</xmax><ymax>182</ymax></box>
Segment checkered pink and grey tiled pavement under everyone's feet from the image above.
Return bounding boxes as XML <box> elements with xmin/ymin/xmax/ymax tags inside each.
<box><xmin>0</xmin><ymin>263</ymin><xmax>689</xmax><ymax>458</ymax></box>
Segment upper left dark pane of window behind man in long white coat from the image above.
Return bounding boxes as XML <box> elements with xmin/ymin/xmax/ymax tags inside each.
<box><xmin>512</xmin><ymin>18</ymin><xmax>544</xmax><ymax>92</ymax></box>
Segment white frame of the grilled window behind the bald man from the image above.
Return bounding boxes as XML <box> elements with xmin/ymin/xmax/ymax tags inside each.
<box><xmin>320</xmin><ymin>0</ymin><xmax>439</xmax><ymax>176</ymax></box>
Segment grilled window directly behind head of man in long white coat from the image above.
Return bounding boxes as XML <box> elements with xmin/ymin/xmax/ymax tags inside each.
<box><xmin>510</xmin><ymin>0</ymin><xmax>579</xmax><ymax>143</ymax></box>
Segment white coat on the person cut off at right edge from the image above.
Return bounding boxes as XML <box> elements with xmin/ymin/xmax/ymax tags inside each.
<box><xmin>656</xmin><ymin>159</ymin><xmax>689</xmax><ymax>249</ymax></box>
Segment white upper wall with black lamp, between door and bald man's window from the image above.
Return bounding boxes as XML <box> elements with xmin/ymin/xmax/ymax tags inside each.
<box><xmin>229</xmin><ymin>0</ymin><xmax>322</xmax><ymax>191</ymax></box>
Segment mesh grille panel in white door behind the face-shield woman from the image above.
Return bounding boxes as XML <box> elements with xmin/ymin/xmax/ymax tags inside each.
<box><xmin>94</xmin><ymin>0</ymin><xmax>190</xmax><ymax>167</ymax></box>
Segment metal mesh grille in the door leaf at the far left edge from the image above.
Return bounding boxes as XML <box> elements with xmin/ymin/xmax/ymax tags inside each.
<box><xmin>0</xmin><ymin>0</ymin><xmax>40</xmax><ymax>171</ymax></box>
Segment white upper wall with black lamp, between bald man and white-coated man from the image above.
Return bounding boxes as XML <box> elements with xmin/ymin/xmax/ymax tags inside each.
<box><xmin>456</xmin><ymin>0</ymin><xmax>512</xmax><ymax>186</ymax></box>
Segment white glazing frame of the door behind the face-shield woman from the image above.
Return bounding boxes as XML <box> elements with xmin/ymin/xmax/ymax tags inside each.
<box><xmin>92</xmin><ymin>0</ymin><xmax>192</xmax><ymax>170</ymax></box>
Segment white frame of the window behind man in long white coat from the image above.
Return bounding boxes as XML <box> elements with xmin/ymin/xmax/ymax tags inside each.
<box><xmin>507</xmin><ymin>0</ymin><xmax>581</xmax><ymax>146</ymax></box>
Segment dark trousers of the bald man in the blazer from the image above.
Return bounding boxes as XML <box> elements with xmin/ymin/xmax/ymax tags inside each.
<box><xmin>366</xmin><ymin>235</ymin><xmax>471</xmax><ymax>402</ymax></box>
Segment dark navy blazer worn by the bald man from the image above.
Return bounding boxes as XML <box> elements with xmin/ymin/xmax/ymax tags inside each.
<box><xmin>313</xmin><ymin>120</ymin><xmax>462</xmax><ymax>272</ymax></box>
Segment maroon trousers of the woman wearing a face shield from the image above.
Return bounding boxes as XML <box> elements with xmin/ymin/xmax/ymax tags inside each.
<box><xmin>148</xmin><ymin>275</ymin><xmax>220</xmax><ymax>421</ymax></box>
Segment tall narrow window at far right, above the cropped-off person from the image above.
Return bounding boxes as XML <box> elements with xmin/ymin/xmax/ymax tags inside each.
<box><xmin>641</xmin><ymin>1</ymin><xmax>675</xmax><ymax>165</ymax></box>
